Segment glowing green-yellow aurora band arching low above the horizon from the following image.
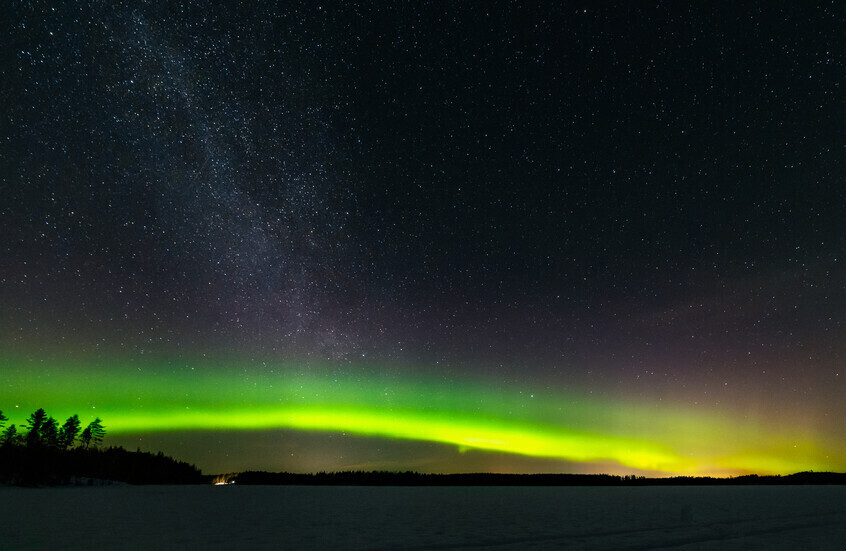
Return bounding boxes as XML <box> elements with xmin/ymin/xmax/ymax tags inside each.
<box><xmin>0</xmin><ymin>358</ymin><xmax>846</xmax><ymax>475</ymax></box>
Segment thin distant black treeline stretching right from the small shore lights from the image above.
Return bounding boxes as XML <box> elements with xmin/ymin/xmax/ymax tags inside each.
<box><xmin>229</xmin><ymin>471</ymin><xmax>846</xmax><ymax>486</ymax></box>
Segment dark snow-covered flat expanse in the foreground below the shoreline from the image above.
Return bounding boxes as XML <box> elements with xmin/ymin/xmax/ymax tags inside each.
<box><xmin>0</xmin><ymin>485</ymin><xmax>846</xmax><ymax>550</ymax></box>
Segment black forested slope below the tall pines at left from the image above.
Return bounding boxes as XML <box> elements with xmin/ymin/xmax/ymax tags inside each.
<box><xmin>0</xmin><ymin>446</ymin><xmax>210</xmax><ymax>486</ymax></box>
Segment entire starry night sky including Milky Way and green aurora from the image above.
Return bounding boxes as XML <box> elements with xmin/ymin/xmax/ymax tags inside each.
<box><xmin>0</xmin><ymin>1</ymin><xmax>846</xmax><ymax>475</ymax></box>
